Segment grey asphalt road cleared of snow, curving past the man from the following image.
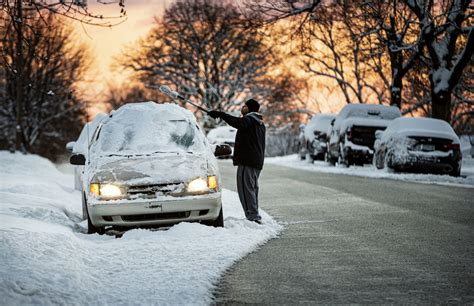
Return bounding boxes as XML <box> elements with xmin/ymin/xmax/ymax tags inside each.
<box><xmin>215</xmin><ymin>161</ymin><xmax>474</xmax><ymax>304</ymax></box>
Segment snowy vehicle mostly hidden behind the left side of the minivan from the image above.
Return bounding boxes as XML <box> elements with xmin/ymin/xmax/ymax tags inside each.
<box><xmin>66</xmin><ymin>113</ymin><xmax>107</xmax><ymax>190</ymax></box>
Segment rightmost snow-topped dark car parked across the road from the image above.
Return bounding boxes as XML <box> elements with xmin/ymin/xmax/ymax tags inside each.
<box><xmin>374</xmin><ymin>118</ymin><xmax>462</xmax><ymax>176</ymax></box>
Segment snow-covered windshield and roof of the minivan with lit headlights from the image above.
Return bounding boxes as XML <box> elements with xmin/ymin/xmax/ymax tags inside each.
<box><xmin>95</xmin><ymin>102</ymin><xmax>205</xmax><ymax>155</ymax></box>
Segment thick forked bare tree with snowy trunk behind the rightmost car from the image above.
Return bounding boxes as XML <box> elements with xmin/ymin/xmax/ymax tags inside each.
<box><xmin>405</xmin><ymin>0</ymin><xmax>474</xmax><ymax>122</ymax></box>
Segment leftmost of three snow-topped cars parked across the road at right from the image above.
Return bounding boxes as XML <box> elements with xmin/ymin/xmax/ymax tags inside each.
<box><xmin>299</xmin><ymin>114</ymin><xmax>336</xmax><ymax>162</ymax></box>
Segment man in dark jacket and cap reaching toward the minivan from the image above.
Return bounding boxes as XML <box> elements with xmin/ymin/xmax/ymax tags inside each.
<box><xmin>209</xmin><ymin>99</ymin><xmax>265</xmax><ymax>224</ymax></box>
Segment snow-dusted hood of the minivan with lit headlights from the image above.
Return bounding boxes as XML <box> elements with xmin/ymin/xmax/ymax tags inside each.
<box><xmin>90</xmin><ymin>153</ymin><xmax>215</xmax><ymax>185</ymax></box>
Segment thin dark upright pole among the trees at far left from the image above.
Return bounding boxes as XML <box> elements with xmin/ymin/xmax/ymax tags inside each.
<box><xmin>14</xmin><ymin>0</ymin><xmax>24</xmax><ymax>151</ymax></box>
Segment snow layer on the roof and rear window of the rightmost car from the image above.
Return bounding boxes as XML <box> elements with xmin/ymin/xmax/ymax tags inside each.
<box><xmin>383</xmin><ymin>117</ymin><xmax>459</xmax><ymax>143</ymax></box>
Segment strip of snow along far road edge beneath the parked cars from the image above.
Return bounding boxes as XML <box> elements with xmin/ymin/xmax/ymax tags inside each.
<box><xmin>265</xmin><ymin>154</ymin><xmax>474</xmax><ymax>188</ymax></box>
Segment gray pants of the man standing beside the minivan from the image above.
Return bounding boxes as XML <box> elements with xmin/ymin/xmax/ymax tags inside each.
<box><xmin>237</xmin><ymin>165</ymin><xmax>262</xmax><ymax>221</ymax></box>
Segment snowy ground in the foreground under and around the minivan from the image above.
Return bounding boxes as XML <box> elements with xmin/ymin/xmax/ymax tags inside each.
<box><xmin>0</xmin><ymin>151</ymin><xmax>281</xmax><ymax>305</ymax></box>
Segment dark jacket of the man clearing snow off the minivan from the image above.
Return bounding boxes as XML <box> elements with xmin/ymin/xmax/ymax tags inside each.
<box><xmin>219</xmin><ymin>112</ymin><xmax>266</xmax><ymax>169</ymax></box>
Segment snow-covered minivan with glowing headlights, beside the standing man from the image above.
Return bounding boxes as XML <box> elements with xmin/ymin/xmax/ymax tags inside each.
<box><xmin>70</xmin><ymin>102</ymin><xmax>230</xmax><ymax>233</ymax></box>
